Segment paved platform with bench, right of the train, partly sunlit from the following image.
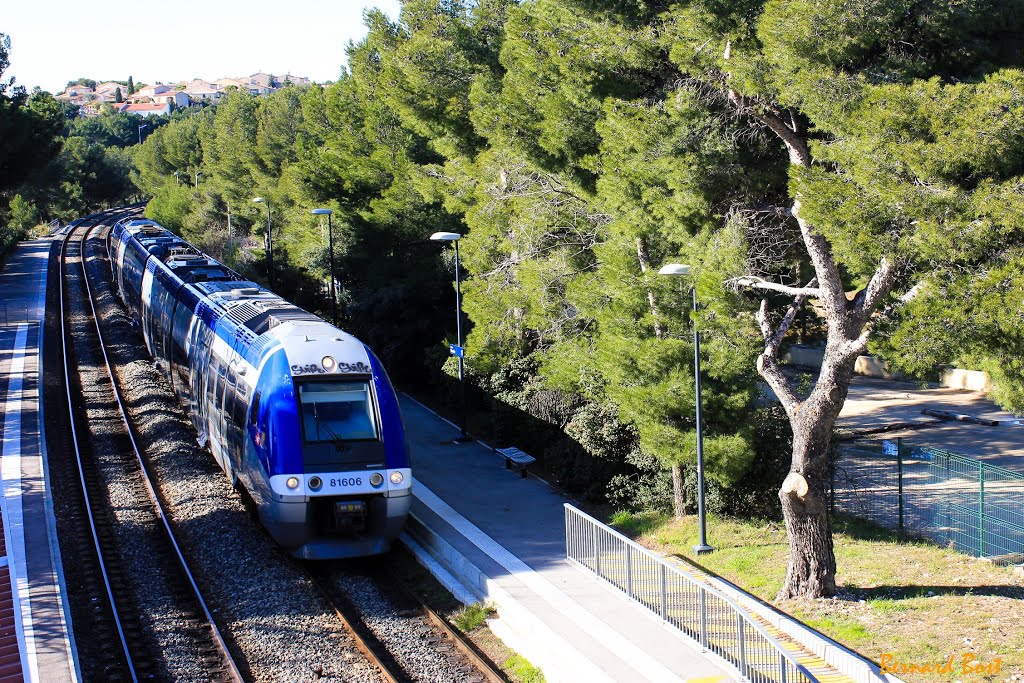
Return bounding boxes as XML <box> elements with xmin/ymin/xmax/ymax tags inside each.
<box><xmin>401</xmin><ymin>395</ymin><xmax>737</xmax><ymax>683</ymax></box>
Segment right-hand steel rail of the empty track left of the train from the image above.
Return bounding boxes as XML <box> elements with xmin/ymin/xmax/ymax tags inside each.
<box><xmin>81</xmin><ymin>218</ymin><xmax>244</xmax><ymax>683</ymax></box>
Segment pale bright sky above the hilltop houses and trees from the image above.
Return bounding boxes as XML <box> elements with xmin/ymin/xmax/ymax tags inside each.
<box><xmin>0</xmin><ymin>0</ymin><xmax>399</xmax><ymax>94</ymax></box>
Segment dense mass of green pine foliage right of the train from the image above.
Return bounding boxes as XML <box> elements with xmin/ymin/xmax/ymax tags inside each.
<box><xmin>108</xmin><ymin>0</ymin><xmax>1024</xmax><ymax>528</ymax></box>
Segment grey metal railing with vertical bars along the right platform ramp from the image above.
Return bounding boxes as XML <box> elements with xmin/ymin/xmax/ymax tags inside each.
<box><xmin>565</xmin><ymin>504</ymin><xmax>817</xmax><ymax>683</ymax></box>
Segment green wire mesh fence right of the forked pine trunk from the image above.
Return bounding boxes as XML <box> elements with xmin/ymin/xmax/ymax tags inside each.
<box><xmin>831</xmin><ymin>438</ymin><xmax>1024</xmax><ymax>563</ymax></box>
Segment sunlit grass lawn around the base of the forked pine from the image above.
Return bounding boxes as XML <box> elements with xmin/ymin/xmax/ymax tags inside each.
<box><xmin>612</xmin><ymin>513</ymin><xmax>1024</xmax><ymax>683</ymax></box>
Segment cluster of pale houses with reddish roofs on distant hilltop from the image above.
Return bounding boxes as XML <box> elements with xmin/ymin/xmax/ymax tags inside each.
<box><xmin>57</xmin><ymin>72</ymin><xmax>311</xmax><ymax>117</ymax></box>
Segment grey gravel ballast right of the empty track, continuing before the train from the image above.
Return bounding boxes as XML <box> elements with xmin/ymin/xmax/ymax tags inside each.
<box><xmin>72</xmin><ymin>230</ymin><xmax>491</xmax><ymax>683</ymax></box>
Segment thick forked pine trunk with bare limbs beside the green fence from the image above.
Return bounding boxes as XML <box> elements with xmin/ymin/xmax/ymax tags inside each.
<box><xmin>726</xmin><ymin>88</ymin><xmax>899</xmax><ymax>599</ymax></box>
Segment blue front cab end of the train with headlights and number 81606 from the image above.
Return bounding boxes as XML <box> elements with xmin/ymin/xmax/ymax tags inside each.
<box><xmin>243</xmin><ymin>353</ymin><xmax>412</xmax><ymax>559</ymax></box>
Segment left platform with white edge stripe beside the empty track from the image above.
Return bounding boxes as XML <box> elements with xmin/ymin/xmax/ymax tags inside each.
<box><xmin>0</xmin><ymin>240</ymin><xmax>79</xmax><ymax>683</ymax></box>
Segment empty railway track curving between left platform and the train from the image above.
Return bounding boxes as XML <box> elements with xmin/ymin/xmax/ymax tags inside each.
<box><xmin>59</xmin><ymin>212</ymin><xmax>243</xmax><ymax>681</ymax></box>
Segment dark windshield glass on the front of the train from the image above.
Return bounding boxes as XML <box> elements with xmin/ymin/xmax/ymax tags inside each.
<box><xmin>298</xmin><ymin>382</ymin><xmax>377</xmax><ymax>443</ymax></box>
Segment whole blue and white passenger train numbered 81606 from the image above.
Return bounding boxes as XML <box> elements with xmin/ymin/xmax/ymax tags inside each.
<box><xmin>106</xmin><ymin>219</ymin><xmax>412</xmax><ymax>559</ymax></box>
